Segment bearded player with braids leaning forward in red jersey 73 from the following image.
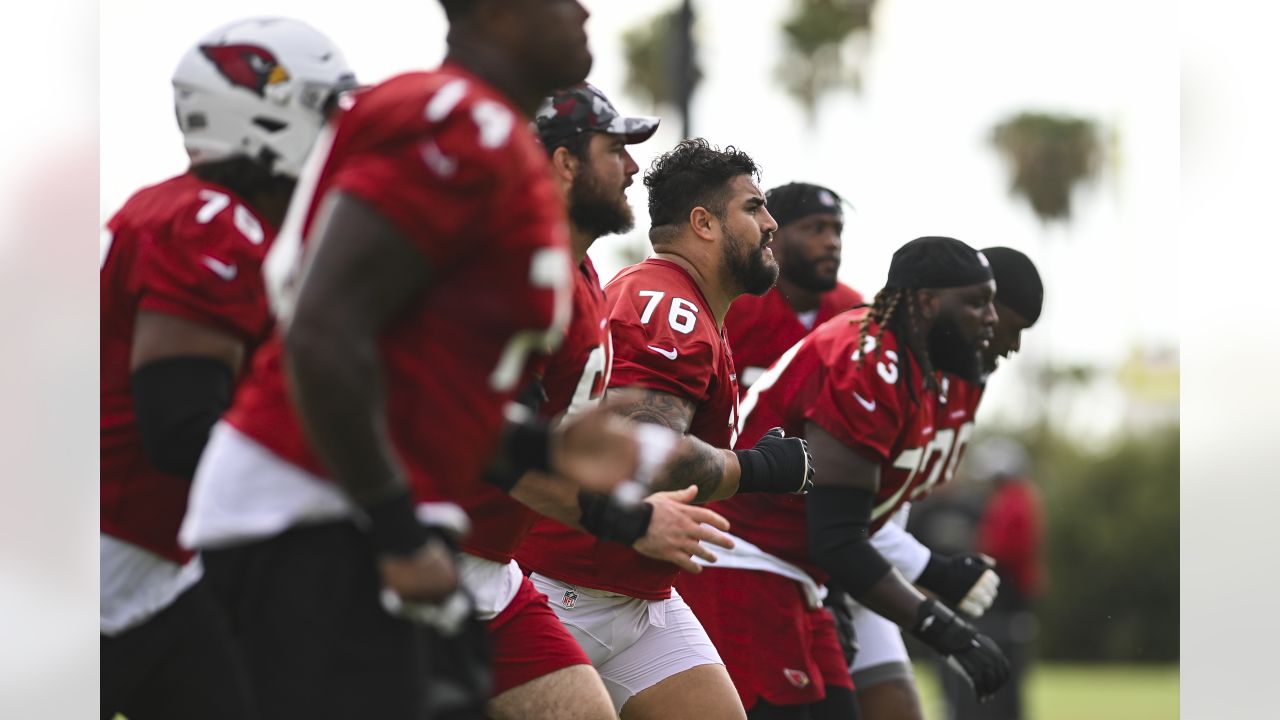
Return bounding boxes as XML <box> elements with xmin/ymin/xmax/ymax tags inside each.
<box><xmin>680</xmin><ymin>237</ymin><xmax>1006</xmax><ymax>719</ymax></box>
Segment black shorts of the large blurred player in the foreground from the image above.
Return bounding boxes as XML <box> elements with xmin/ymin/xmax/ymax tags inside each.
<box><xmin>200</xmin><ymin>523</ymin><xmax>429</xmax><ymax>720</ymax></box>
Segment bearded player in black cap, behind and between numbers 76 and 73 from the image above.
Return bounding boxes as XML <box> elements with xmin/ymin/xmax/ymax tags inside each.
<box><xmin>724</xmin><ymin>182</ymin><xmax>863</xmax><ymax>392</ymax></box>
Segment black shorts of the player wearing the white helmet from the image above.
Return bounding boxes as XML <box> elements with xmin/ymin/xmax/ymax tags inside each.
<box><xmin>99</xmin><ymin>580</ymin><xmax>253</xmax><ymax>720</ymax></box>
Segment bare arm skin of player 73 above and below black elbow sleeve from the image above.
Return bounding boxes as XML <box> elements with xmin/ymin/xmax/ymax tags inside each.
<box><xmin>805</xmin><ymin>423</ymin><xmax>925</xmax><ymax>628</ymax></box>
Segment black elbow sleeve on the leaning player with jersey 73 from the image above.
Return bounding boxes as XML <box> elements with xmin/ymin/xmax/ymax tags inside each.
<box><xmin>805</xmin><ymin>486</ymin><xmax>891</xmax><ymax>600</ymax></box>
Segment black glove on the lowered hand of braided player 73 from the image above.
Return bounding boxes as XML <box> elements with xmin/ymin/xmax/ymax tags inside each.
<box><xmin>911</xmin><ymin>598</ymin><xmax>1009</xmax><ymax>702</ymax></box>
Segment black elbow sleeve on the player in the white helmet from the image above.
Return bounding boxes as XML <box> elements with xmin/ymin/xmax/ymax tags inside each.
<box><xmin>129</xmin><ymin>356</ymin><xmax>233</xmax><ymax>479</ymax></box>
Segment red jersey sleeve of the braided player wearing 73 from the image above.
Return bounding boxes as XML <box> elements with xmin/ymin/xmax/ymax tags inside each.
<box><xmin>805</xmin><ymin>333</ymin><xmax>909</xmax><ymax>461</ymax></box>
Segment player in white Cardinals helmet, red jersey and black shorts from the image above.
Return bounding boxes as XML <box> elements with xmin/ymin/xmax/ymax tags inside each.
<box><xmin>100</xmin><ymin>18</ymin><xmax>355</xmax><ymax>720</ymax></box>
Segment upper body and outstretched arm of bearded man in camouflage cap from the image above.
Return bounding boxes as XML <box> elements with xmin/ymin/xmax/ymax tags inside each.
<box><xmin>507</xmin><ymin>83</ymin><xmax>727</xmax><ymax>573</ymax></box>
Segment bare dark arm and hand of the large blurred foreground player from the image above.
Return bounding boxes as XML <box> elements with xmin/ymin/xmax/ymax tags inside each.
<box><xmin>284</xmin><ymin>192</ymin><xmax>457</xmax><ymax>602</ymax></box>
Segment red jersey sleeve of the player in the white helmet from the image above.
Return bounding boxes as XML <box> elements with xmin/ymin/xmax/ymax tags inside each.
<box><xmin>133</xmin><ymin>188</ymin><xmax>275</xmax><ymax>342</ymax></box>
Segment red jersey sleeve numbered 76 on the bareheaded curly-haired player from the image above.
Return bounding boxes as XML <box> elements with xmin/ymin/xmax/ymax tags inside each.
<box><xmin>609</xmin><ymin>283</ymin><xmax>718</xmax><ymax>402</ymax></box>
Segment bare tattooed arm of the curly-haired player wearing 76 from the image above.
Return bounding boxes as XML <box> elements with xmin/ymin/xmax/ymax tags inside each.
<box><xmin>607</xmin><ymin>387</ymin><xmax>741</xmax><ymax>502</ymax></box>
